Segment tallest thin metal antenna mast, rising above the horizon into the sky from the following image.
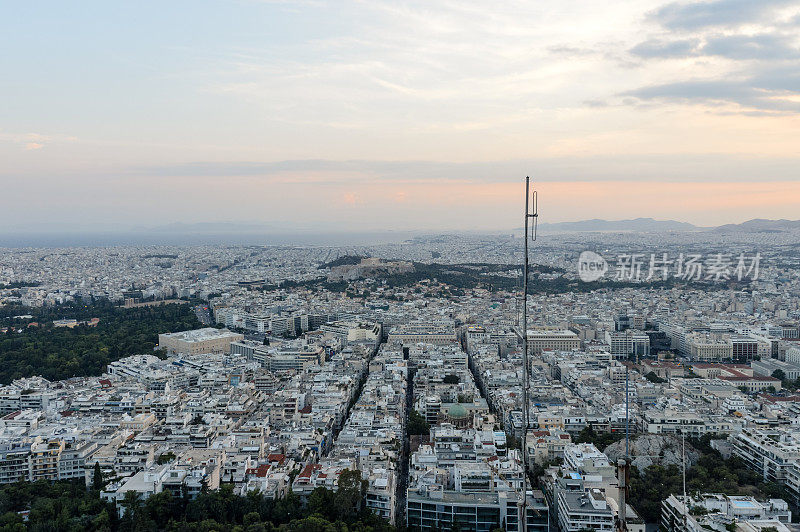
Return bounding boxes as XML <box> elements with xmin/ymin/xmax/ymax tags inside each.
<box><xmin>520</xmin><ymin>176</ymin><xmax>539</xmax><ymax>532</ymax></box>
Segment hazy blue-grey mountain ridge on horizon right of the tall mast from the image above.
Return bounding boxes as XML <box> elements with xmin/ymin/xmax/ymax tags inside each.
<box><xmin>539</xmin><ymin>218</ymin><xmax>800</xmax><ymax>233</ymax></box>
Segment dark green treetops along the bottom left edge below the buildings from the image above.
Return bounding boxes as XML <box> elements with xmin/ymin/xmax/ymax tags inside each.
<box><xmin>0</xmin><ymin>471</ymin><xmax>393</xmax><ymax>532</ymax></box>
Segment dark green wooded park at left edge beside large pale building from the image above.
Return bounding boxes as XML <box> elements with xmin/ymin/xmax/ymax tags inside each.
<box><xmin>0</xmin><ymin>301</ymin><xmax>201</xmax><ymax>384</ymax></box>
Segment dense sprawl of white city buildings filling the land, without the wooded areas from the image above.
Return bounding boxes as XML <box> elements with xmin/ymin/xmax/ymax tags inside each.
<box><xmin>0</xmin><ymin>231</ymin><xmax>800</xmax><ymax>532</ymax></box>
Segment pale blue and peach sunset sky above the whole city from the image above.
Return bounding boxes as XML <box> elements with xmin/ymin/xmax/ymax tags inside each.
<box><xmin>0</xmin><ymin>0</ymin><xmax>800</xmax><ymax>231</ymax></box>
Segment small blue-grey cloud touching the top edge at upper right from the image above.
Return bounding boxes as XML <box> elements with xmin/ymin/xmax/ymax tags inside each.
<box><xmin>650</xmin><ymin>0</ymin><xmax>793</xmax><ymax>30</ymax></box>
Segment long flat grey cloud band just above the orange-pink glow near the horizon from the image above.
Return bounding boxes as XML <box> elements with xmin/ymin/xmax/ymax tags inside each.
<box><xmin>122</xmin><ymin>155</ymin><xmax>800</xmax><ymax>186</ymax></box>
